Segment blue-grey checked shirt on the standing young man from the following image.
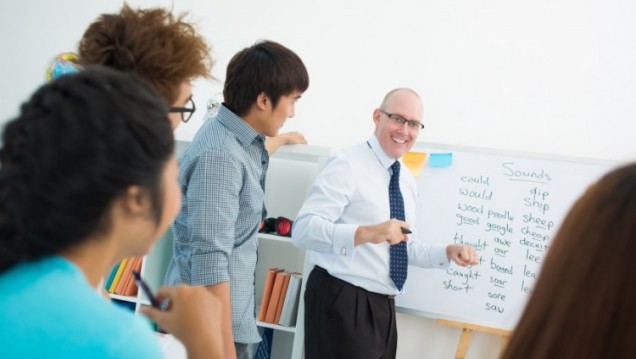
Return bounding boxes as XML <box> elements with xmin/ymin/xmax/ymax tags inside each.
<box><xmin>165</xmin><ymin>106</ymin><xmax>269</xmax><ymax>343</ymax></box>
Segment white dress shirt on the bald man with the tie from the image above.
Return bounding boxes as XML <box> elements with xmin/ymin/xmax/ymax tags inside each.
<box><xmin>292</xmin><ymin>135</ymin><xmax>449</xmax><ymax>295</ymax></box>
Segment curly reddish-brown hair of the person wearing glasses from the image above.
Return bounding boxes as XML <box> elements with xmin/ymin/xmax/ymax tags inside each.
<box><xmin>78</xmin><ymin>5</ymin><xmax>213</xmax><ymax>105</ymax></box>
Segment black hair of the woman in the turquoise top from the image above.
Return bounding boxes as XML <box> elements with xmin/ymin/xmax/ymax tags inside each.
<box><xmin>0</xmin><ymin>67</ymin><xmax>174</xmax><ymax>272</ymax></box>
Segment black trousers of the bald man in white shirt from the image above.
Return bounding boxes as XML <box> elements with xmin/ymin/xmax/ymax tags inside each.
<box><xmin>305</xmin><ymin>266</ymin><xmax>397</xmax><ymax>359</ymax></box>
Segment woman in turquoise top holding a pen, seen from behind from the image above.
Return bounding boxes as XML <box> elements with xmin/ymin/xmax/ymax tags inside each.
<box><xmin>0</xmin><ymin>67</ymin><xmax>222</xmax><ymax>359</ymax></box>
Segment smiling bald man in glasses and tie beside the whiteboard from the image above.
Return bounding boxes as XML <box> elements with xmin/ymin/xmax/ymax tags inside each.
<box><xmin>292</xmin><ymin>88</ymin><xmax>477</xmax><ymax>359</ymax></box>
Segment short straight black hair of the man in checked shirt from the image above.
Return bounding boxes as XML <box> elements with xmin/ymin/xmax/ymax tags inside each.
<box><xmin>223</xmin><ymin>41</ymin><xmax>309</xmax><ymax>116</ymax></box>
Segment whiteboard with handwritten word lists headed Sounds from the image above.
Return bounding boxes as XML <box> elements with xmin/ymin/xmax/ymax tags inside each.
<box><xmin>396</xmin><ymin>143</ymin><xmax>616</xmax><ymax>329</ymax></box>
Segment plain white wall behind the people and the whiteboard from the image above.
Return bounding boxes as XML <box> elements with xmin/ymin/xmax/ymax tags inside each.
<box><xmin>0</xmin><ymin>0</ymin><xmax>636</xmax><ymax>358</ymax></box>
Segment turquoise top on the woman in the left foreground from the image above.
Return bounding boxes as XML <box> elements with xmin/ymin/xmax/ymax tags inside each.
<box><xmin>0</xmin><ymin>257</ymin><xmax>163</xmax><ymax>359</ymax></box>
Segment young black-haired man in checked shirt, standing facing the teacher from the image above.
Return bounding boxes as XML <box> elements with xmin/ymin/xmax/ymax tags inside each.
<box><xmin>165</xmin><ymin>41</ymin><xmax>309</xmax><ymax>359</ymax></box>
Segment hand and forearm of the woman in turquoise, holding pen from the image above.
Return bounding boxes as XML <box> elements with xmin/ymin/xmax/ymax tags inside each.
<box><xmin>140</xmin><ymin>285</ymin><xmax>226</xmax><ymax>359</ymax></box>
